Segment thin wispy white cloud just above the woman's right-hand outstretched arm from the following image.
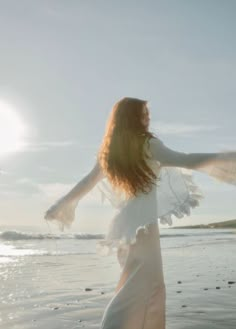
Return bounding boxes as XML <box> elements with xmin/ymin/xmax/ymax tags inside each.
<box><xmin>152</xmin><ymin>121</ymin><xmax>220</xmax><ymax>136</ymax></box>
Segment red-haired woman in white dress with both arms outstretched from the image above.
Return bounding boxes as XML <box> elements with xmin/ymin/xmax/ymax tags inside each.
<box><xmin>45</xmin><ymin>97</ymin><xmax>236</xmax><ymax>329</ymax></box>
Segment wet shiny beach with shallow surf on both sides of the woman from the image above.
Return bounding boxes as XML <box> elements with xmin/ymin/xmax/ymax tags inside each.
<box><xmin>0</xmin><ymin>228</ymin><xmax>236</xmax><ymax>329</ymax></box>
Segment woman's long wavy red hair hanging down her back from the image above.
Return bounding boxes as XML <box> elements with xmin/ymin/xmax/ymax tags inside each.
<box><xmin>98</xmin><ymin>97</ymin><xmax>157</xmax><ymax>197</ymax></box>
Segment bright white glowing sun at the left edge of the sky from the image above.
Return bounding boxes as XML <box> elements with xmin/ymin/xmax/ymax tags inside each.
<box><xmin>0</xmin><ymin>100</ymin><xmax>27</xmax><ymax>156</ymax></box>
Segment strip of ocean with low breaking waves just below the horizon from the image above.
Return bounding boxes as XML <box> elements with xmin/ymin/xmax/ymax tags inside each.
<box><xmin>0</xmin><ymin>227</ymin><xmax>236</xmax><ymax>263</ymax></box>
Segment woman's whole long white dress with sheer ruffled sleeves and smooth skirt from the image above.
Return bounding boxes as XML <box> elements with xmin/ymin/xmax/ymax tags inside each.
<box><xmin>45</xmin><ymin>138</ymin><xmax>236</xmax><ymax>329</ymax></box>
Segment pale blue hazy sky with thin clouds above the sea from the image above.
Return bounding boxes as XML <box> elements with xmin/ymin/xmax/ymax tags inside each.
<box><xmin>0</xmin><ymin>0</ymin><xmax>236</xmax><ymax>233</ymax></box>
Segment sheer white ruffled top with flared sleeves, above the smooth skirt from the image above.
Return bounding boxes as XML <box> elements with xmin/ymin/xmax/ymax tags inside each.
<box><xmin>45</xmin><ymin>138</ymin><xmax>236</xmax><ymax>255</ymax></box>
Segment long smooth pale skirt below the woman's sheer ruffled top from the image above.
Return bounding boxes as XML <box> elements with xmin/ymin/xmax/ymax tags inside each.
<box><xmin>100</xmin><ymin>222</ymin><xmax>166</xmax><ymax>329</ymax></box>
